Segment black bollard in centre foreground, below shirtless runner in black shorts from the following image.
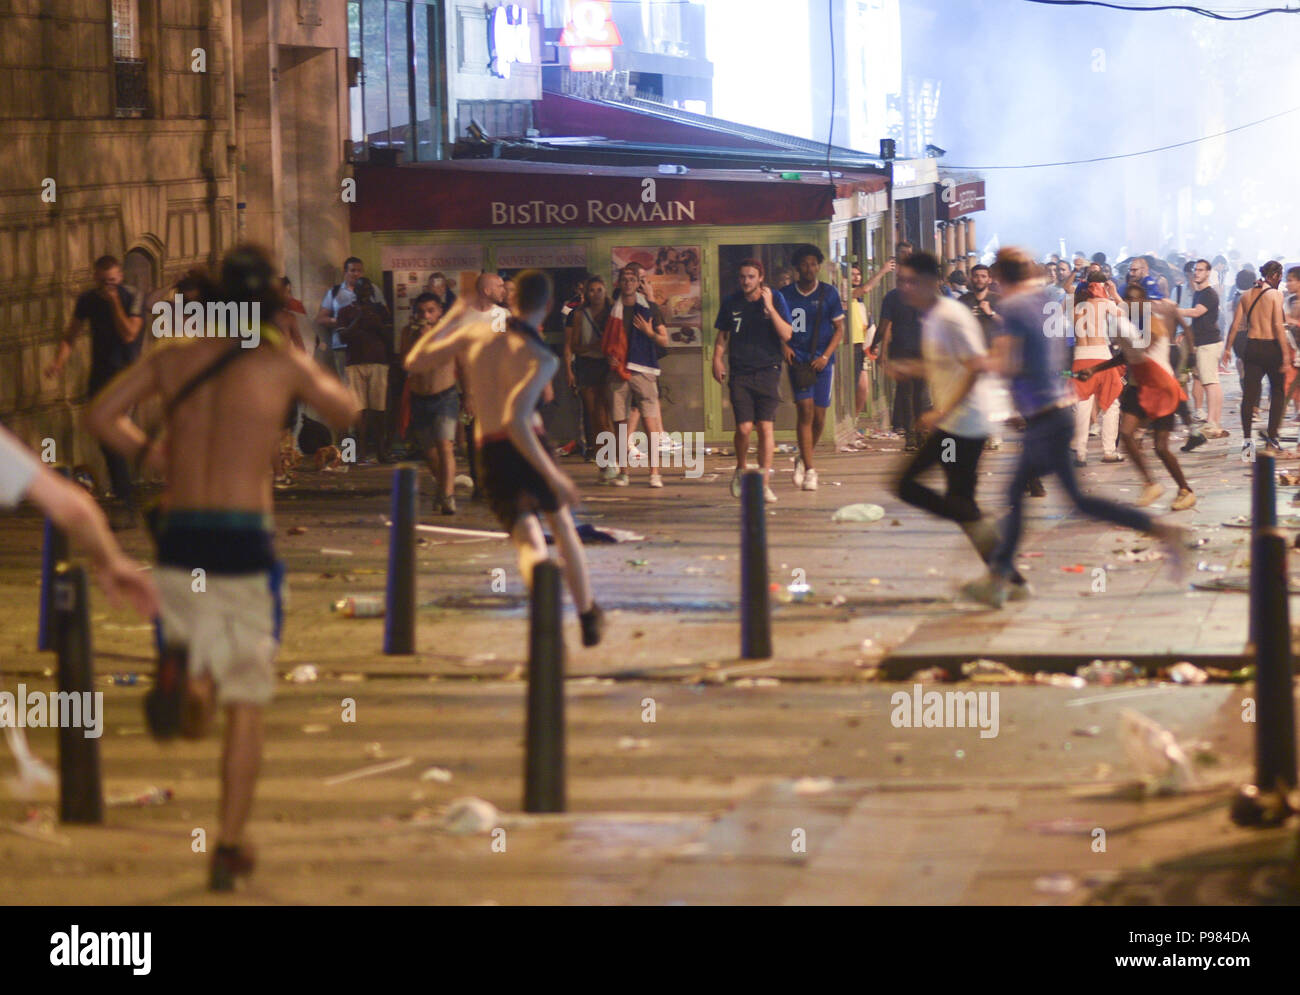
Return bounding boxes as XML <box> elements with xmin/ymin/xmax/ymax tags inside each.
<box><xmin>524</xmin><ymin>559</ymin><xmax>564</xmax><ymax>812</ymax></box>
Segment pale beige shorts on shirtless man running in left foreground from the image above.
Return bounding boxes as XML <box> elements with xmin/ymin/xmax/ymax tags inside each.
<box><xmin>153</xmin><ymin>566</ymin><xmax>282</xmax><ymax>705</ymax></box>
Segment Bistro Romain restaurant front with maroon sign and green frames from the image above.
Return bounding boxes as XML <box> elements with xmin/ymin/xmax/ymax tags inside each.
<box><xmin>351</xmin><ymin>160</ymin><xmax>892</xmax><ymax>442</ymax></box>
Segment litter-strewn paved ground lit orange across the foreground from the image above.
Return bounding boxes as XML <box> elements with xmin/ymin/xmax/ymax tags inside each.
<box><xmin>0</xmin><ymin>364</ymin><xmax>1296</xmax><ymax>904</ymax></box>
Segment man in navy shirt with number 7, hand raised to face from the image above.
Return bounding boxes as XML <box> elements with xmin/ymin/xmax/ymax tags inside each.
<box><xmin>714</xmin><ymin>259</ymin><xmax>793</xmax><ymax>502</ymax></box>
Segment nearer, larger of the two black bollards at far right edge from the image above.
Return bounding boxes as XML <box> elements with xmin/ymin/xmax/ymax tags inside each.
<box><xmin>1251</xmin><ymin>529</ymin><xmax>1296</xmax><ymax>792</ymax></box>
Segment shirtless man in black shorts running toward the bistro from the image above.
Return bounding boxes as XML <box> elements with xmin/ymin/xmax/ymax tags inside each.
<box><xmin>406</xmin><ymin>269</ymin><xmax>605</xmax><ymax>646</ymax></box>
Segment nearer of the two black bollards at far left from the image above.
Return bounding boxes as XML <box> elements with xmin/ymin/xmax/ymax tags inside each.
<box><xmin>49</xmin><ymin>564</ymin><xmax>104</xmax><ymax>825</ymax></box>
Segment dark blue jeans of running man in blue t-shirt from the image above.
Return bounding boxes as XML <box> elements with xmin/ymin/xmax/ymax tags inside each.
<box><xmin>989</xmin><ymin>407</ymin><xmax>1153</xmax><ymax>577</ymax></box>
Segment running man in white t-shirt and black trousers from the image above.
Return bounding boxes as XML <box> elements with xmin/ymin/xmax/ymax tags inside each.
<box><xmin>894</xmin><ymin>252</ymin><xmax>1028</xmax><ymax>598</ymax></box>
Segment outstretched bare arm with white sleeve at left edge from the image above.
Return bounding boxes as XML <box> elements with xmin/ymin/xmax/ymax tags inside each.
<box><xmin>0</xmin><ymin>428</ymin><xmax>159</xmax><ymax>619</ymax></box>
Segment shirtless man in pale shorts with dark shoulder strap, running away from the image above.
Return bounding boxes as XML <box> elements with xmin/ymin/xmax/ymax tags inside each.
<box><xmin>86</xmin><ymin>247</ymin><xmax>359</xmax><ymax>891</ymax></box>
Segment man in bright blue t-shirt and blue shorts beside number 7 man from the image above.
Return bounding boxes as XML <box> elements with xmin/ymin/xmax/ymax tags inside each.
<box><xmin>780</xmin><ymin>246</ymin><xmax>844</xmax><ymax>490</ymax></box>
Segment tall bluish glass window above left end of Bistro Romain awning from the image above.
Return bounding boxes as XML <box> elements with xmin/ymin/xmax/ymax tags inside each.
<box><xmin>347</xmin><ymin>0</ymin><xmax>443</xmax><ymax>161</ymax></box>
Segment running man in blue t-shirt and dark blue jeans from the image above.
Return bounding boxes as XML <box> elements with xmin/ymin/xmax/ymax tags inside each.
<box><xmin>962</xmin><ymin>248</ymin><xmax>1183</xmax><ymax>607</ymax></box>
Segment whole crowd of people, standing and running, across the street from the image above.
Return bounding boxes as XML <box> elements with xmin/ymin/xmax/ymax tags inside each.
<box><xmin>17</xmin><ymin>235</ymin><xmax>1300</xmax><ymax>888</ymax></box>
